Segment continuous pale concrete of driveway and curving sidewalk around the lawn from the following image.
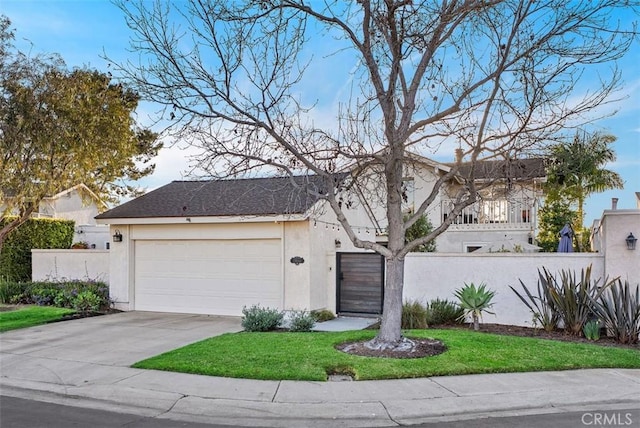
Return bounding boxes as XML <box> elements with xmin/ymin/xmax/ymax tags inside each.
<box><xmin>0</xmin><ymin>312</ymin><xmax>640</xmax><ymax>427</ymax></box>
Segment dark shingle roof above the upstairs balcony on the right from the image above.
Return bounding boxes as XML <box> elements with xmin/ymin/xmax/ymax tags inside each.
<box><xmin>447</xmin><ymin>158</ymin><xmax>547</xmax><ymax>180</ymax></box>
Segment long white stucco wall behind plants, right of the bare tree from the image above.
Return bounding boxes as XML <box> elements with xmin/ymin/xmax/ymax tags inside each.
<box><xmin>404</xmin><ymin>253</ymin><xmax>604</xmax><ymax>326</ymax></box>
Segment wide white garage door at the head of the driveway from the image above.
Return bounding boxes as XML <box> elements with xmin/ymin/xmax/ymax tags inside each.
<box><xmin>134</xmin><ymin>239</ymin><xmax>282</xmax><ymax>315</ymax></box>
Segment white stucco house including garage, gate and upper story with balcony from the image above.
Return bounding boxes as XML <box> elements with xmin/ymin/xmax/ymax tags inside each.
<box><xmin>96</xmin><ymin>152</ymin><xmax>548</xmax><ymax>315</ymax></box>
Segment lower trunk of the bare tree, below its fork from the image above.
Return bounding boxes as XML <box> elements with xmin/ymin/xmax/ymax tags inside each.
<box><xmin>374</xmin><ymin>258</ymin><xmax>404</xmax><ymax>347</ymax></box>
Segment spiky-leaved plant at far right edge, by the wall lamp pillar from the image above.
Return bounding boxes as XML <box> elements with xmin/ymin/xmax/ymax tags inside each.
<box><xmin>591</xmin><ymin>279</ymin><xmax>640</xmax><ymax>343</ymax></box>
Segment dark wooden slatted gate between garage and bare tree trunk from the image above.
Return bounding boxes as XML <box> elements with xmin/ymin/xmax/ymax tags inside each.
<box><xmin>336</xmin><ymin>253</ymin><xmax>384</xmax><ymax>314</ymax></box>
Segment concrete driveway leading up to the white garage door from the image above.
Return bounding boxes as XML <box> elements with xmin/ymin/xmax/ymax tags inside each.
<box><xmin>0</xmin><ymin>312</ymin><xmax>242</xmax><ymax>366</ymax></box>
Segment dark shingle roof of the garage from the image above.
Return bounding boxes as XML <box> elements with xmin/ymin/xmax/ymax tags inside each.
<box><xmin>96</xmin><ymin>176</ymin><xmax>336</xmax><ymax>219</ymax></box>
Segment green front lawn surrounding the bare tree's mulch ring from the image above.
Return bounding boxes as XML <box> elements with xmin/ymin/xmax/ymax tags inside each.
<box><xmin>134</xmin><ymin>329</ymin><xmax>640</xmax><ymax>380</ymax></box>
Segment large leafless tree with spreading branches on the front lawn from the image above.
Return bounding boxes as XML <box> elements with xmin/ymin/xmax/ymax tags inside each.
<box><xmin>117</xmin><ymin>0</ymin><xmax>638</xmax><ymax>347</ymax></box>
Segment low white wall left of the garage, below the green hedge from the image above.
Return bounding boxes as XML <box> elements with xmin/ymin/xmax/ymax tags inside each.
<box><xmin>31</xmin><ymin>250</ymin><xmax>109</xmax><ymax>284</ymax></box>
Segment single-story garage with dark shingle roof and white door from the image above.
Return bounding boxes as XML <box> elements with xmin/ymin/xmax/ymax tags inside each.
<box><xmin>97</xmin><ymin>177</ymin><xmax>372</xmax><ymax>315</ymax></box>
